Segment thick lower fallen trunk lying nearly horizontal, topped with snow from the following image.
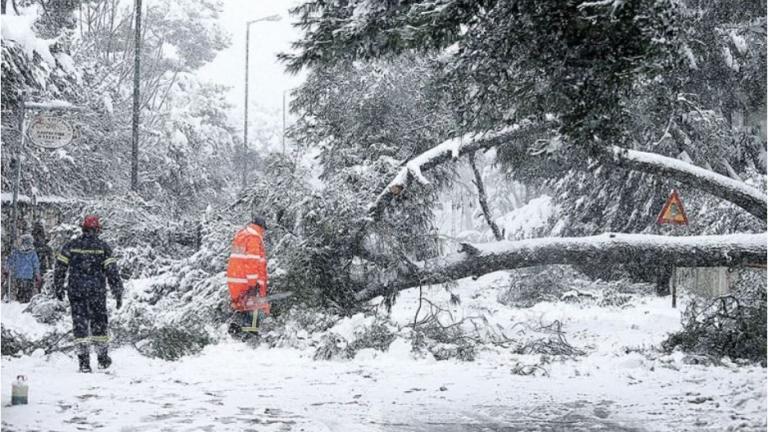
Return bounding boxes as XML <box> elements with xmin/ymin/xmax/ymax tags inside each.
<box><xmin>355</xmin><ymin>233</ymin><xmax>768</xmax><ymax>301</ymax></box>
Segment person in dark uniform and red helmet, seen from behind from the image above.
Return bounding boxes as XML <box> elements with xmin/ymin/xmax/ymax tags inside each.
<box><xmin>54</xmin><ymin>215</ymin><xmax>123</xmax><ymax>372</ymax></box>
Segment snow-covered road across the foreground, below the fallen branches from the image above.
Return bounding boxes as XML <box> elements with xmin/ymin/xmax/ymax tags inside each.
<box><xmin>2</xmin><ymin>343</ymin><xmax>765</xmax><ymax>431</ymax></box>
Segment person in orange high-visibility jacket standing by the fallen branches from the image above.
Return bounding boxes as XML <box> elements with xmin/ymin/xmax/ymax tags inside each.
<box><xmin>227</xmin><ymin>216</ymin><xmax>270</xmax><ymax>333</ymax></box>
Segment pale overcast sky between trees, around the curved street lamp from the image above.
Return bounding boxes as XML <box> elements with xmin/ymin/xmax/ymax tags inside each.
<box><xmin>200</xmin><ymin>0</ymin><xmax>303</xmax><ymax>123</ymax></box>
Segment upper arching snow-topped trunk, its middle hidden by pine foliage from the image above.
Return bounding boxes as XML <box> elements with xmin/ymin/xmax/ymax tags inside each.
<box><xmin>369</xmin><ymin>123</ymin><xmax>768</xmax><ymax>222</ymax></box>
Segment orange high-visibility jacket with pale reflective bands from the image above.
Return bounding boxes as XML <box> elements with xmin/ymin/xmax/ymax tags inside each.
<box><xmin>227</xmin><ymin>224</ymin><xmax>269</xmax><ymax>314</ymax></box>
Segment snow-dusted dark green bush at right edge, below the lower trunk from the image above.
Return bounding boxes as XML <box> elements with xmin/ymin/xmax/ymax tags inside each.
<box><xmin>662</xmin><ymin>270</ymin><xmax>766</xmax><ymax>365</ymax></box>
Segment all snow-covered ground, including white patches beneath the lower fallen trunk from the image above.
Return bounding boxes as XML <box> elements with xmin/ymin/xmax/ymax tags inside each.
<box><xmin>2</xmin><ymin>273</ymin><xmax>766</xmax><ymax>431</ymax></box>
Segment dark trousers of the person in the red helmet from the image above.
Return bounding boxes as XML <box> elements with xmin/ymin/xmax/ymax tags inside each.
<box><xmin>68</xmin><ymin>289</ymin><xmax>109</xmax><ymax>355</ymax></box>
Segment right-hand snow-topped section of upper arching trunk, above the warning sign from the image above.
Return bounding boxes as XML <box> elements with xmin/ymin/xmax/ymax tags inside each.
<box><xmin>606</xmin><ymin>146</ymin><xmax>768</xmax><ymax>221</ymax></box>
